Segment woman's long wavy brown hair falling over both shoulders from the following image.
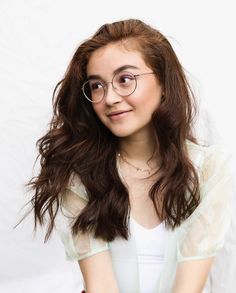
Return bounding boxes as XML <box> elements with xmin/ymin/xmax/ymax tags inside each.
<box><xmin>25</xmin><ymin>19</ymin><xmax>199</xmax><ymax>241</ymax></box>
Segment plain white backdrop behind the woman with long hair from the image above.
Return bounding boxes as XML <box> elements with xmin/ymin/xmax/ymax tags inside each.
<box><xmin>0</xmin><ymin>0</ymin><xmax>236</xmax><ymax>293</ymax></box>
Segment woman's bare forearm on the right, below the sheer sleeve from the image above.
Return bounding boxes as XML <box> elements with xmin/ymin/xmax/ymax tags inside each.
<box><xmin>173</xmin><ymin>257</ymin><xmax>214</xmax><ymax>293</ymax></box>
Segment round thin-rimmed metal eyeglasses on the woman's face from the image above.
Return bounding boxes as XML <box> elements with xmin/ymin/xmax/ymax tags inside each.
<box><xmin>82</xmin><ymin>71</ymin><xmax>154</xmax><ymax>103</ymax></box>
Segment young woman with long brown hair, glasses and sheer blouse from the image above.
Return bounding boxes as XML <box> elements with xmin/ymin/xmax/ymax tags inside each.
<box><xmin>27</xmin><ymin>19</ymin><xmax>231</xmax><ymax>293</ymax></box>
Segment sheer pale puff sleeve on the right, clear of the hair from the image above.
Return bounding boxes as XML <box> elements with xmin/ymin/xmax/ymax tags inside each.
<box><xmin>177</xmin><ymin>146</ymin><xmax>233</xmax><ymax>261</ymax></box>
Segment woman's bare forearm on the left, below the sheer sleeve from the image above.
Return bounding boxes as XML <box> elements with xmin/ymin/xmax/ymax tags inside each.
<box><xmin>79</xmin><ymin>250</ymin><xmax>119</xmax><ymax>293</ymax></box>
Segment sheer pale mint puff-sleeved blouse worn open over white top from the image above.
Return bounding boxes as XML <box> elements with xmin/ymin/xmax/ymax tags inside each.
<box><xmin>56</xmin><ymin>142</ymin><xmax>233</xmax><ymax>293</ymax></box>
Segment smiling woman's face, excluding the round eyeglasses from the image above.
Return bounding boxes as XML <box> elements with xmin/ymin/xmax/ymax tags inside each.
<box><xmin>87</xmin><ymin>44</ymin><xmax>162</xmax><ymax>138</ymax></box>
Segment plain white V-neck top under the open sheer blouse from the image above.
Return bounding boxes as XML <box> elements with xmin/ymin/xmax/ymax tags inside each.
<box><xmin>130</xmin><ymin>216</ymin><xmax>166</xmax><ymax>293</ymax></box>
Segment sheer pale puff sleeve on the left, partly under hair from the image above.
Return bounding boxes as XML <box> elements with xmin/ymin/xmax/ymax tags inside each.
<box><xmin>56</xmin><ymin>175</ymin><xmax>109</xmax><ymax>261</ymax></box>
